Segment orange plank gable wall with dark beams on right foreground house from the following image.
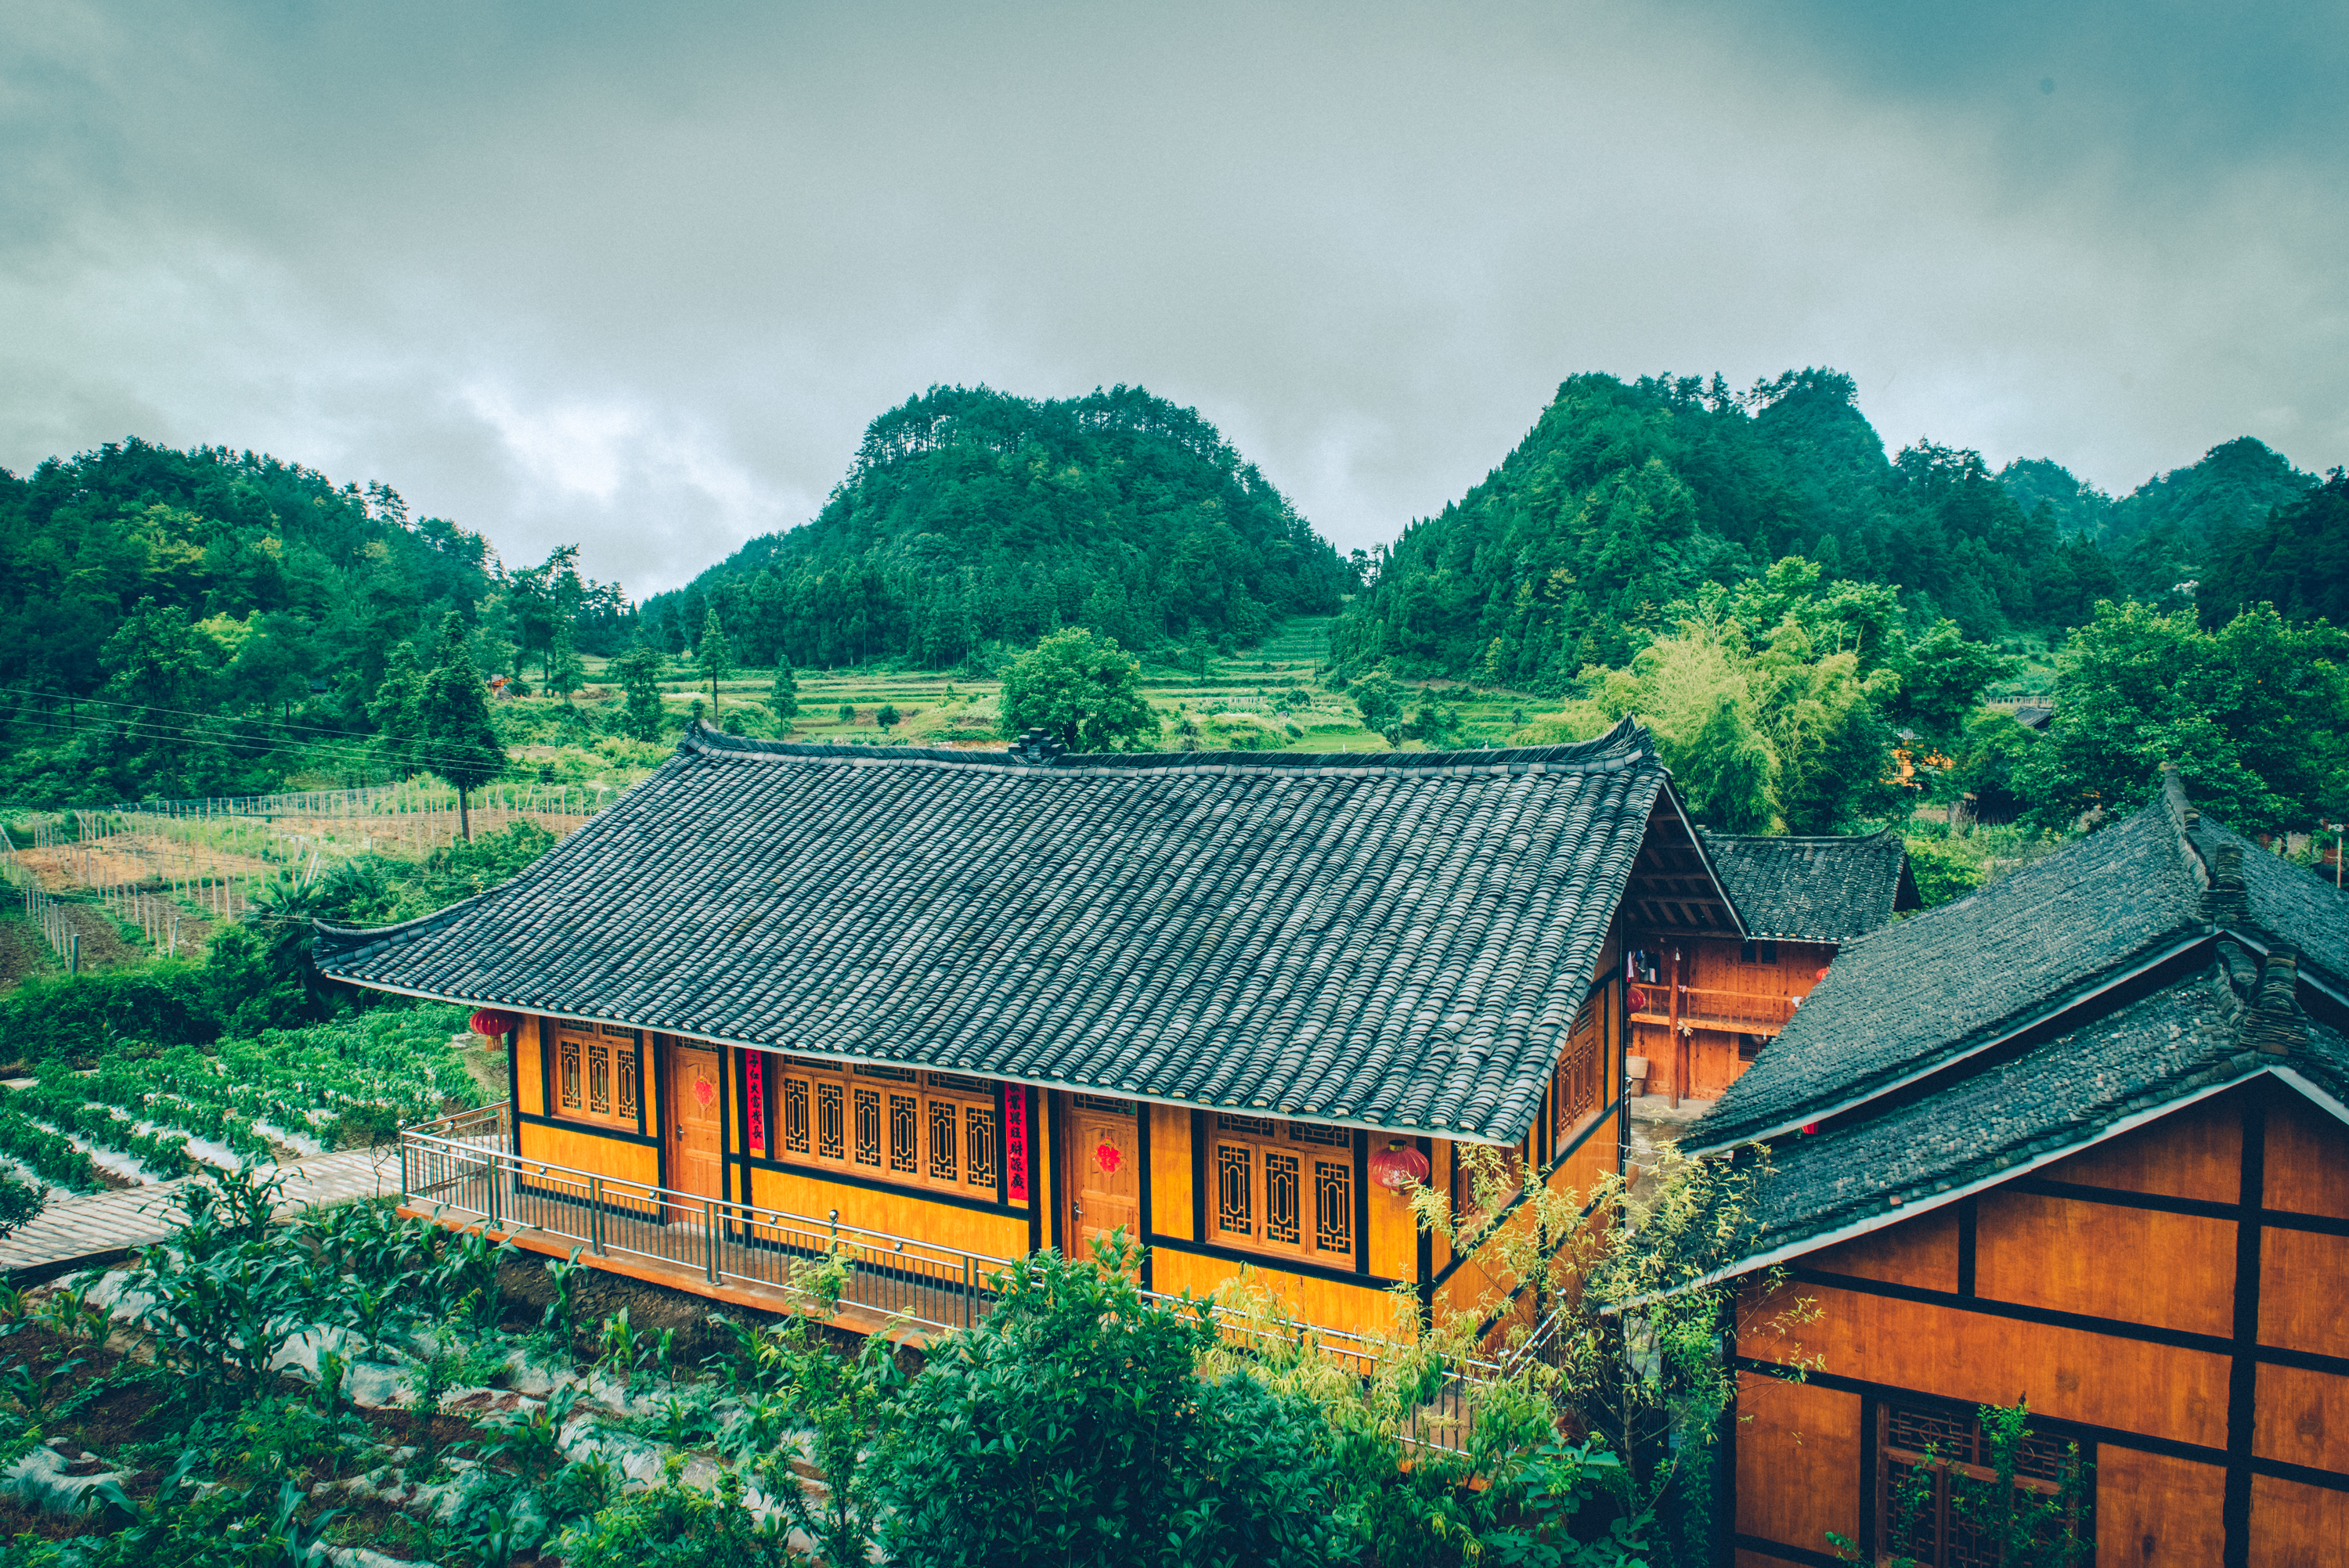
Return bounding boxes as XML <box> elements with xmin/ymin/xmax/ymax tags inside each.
<box><xmin>1734</xmin><ymin>1080</ymin><xmax>2349</xmax><ymax>1568</ymax></box>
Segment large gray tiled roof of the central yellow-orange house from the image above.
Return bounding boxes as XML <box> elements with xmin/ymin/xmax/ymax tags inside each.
<box><xmin>315</xmin><ymin>723</ymin><xmax>1665</xmax><ymax>1141</ymax></box>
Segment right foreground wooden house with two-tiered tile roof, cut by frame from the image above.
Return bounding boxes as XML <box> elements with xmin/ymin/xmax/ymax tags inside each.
<box><xmin>1689</xmin><ymin>775</ymin><xmax>2349</xmax><ymax>1568</ymax></box>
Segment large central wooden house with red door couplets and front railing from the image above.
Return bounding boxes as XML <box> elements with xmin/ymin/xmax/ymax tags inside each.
<box><xmin>317</xmin><ymin>723</ymin><xmax>1743</xmax><ymax>1331</ymax></box>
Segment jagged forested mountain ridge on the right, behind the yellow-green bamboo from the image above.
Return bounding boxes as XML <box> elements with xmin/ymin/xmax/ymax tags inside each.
<box><xmin>1332</xmin><ymin>369</ymin><xmax>2326</xmax><ymax>693</ymax></box>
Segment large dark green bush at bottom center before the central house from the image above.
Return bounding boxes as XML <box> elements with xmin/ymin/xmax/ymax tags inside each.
<box><xmin>876</xmin><ymin>1235</ymin><xmax>1334</xmax><ymax>1568</ymax></box>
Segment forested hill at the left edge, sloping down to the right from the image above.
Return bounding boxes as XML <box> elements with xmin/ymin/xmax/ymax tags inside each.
<box><xmin>0</xmin><ymin>439</ymin><xmax>632</xmax><ymax>798</ymax></box>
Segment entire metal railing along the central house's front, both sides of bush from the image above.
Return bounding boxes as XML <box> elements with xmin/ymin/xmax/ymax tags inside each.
<box><xmin>399</xmin><ymin>1105</ymin><xmax>1506</xmax><ymax>1451</ymax></box>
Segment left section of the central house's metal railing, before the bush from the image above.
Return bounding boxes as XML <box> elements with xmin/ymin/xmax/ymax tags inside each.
<box><xmin>399</xmin><ymin>1105</ymin><xmax>1010</xmax><ymax>1328</ymax></box>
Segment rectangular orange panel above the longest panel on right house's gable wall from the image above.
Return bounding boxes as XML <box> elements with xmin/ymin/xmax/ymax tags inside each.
<box><xmin>1973</xmin><ymin>1192</ymin><xmax>2236</xmax><ymax>1336</ymax></box>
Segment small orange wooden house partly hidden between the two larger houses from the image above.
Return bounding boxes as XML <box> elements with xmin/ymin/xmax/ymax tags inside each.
<box><xmin>1626</xmin><ymin>828</ymin><xmax>1919</xmax><ymax>1105</ymax></box>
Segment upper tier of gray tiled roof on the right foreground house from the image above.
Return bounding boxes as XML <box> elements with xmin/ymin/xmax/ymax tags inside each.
<box><xmin>1689</xmin><ymin>802</ymin><xmax>2199</xmax><ymax>1148</ymax></box>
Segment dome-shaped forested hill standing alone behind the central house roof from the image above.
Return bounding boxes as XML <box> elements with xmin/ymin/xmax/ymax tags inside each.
<box><xmin>646</xmin><ymin>387</ymin><xmax>1353</xmax><ymax>669</ymax></box>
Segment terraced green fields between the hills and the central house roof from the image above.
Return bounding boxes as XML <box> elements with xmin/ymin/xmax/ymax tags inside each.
<box><xmin>576</xmin><ymin>618</ymin><xmax>1588</xmax><ymax>752</ymax></box>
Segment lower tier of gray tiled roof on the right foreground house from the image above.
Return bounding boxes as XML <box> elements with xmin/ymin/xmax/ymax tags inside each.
<box><xmin>1745</xmin><ymin>964</ymin><xmax>2349</xmax><ymax>1256</ymax></box>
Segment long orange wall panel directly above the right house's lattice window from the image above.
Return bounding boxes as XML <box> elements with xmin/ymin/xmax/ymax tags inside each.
<box><xmin>1738</xmin><ymin>1284</ymin><xmax>2227</xmax><ymax>1448</ymax></box>
